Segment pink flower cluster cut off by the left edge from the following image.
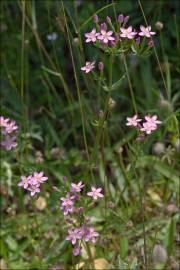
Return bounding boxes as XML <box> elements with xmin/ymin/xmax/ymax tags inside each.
<box><xmin>0</xmin><ymin>116</ymin><xmax>18</xmax><ymax>151</ymax></box>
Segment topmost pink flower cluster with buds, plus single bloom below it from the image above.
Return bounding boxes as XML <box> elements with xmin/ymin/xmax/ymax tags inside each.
<box><xmin>81</xmin><ymin>14</ymin><xmax>156</xmax><ymax>73</ymax></box>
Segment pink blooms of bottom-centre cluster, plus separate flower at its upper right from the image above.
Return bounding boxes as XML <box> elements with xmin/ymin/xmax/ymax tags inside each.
<box><xmin>60</xmin><ymin>181</ymin><xmax>104</xmax><ymax>256</ymax></box>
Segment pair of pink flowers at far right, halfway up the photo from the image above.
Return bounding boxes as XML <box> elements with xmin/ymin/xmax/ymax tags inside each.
<box><xmin>126</xmin><ymin>115</ymin><xmax>162</xmax><ymax>135</ymax></box>
